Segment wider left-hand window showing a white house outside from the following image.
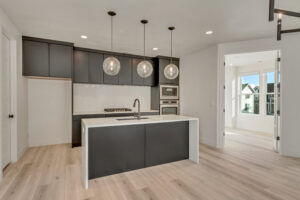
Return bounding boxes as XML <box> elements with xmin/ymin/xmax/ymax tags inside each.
<box><xmin>241</xmin><ymin>74</ymin><xmax>260</xmax><ymax>114</ymax></box>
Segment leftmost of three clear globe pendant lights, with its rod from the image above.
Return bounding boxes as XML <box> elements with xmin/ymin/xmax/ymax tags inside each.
<box><xmin>103</xmin><ymin>11</ymin><xmax>121</xmax><ymax>76</ymax></box>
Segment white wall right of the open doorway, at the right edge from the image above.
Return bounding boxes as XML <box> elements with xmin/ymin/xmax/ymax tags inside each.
<box><xmin>281</xmin><ymin>33</ymin><xmax>300</xmax><ymax>157</ymax></box>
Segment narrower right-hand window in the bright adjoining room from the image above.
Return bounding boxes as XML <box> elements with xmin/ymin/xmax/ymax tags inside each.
<box><xmin>266</xmin><ymin>72</ymin><xmax>275</xmax><ymax>115</ymax></box>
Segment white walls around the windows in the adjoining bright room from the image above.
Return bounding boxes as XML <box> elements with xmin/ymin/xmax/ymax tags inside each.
<box><xmin>225</xmin><ymin>60</ymin><xmax>275</xmax><ymax>134</ymax></box>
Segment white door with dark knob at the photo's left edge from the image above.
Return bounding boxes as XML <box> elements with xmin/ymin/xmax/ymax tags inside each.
<box><xmin>0</xmin><ymin>34</ymin><xmax>11</xmax><ymax>169</ymax></box>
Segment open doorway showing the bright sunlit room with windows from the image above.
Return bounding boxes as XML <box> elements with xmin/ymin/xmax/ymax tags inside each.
<box><xmin>225</xmin><ymin>51</ymin><xmax>280</xmax><ymax>152</ymax></box>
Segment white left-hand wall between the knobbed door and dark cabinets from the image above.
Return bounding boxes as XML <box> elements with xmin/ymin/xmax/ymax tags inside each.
<box><xmin>0</xmin><ymin>8</ymin><xmax>28</xmax><ymax>176</ymax></box>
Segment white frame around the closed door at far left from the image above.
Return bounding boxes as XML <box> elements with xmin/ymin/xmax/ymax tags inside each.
<box><xmin>0</xmin><ymin>26</ymin><xmax>18</xmax><ymax>180</ymax></box>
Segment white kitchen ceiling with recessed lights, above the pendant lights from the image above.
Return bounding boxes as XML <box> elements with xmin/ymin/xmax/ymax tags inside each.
<box><xmin>0</xmin><ymin>0</ymin><xmax>300</xmax><ymax>56</ymax></box>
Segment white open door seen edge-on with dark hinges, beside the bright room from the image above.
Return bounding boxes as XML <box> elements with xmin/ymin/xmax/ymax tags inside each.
<box><xmin>274</xmin><ymin>51</ymin><xmax>281</xmax><ymax>152</ymax></box>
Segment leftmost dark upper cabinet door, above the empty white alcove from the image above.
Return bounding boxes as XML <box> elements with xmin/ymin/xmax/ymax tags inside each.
<box><xmin>23</xmin><ymin>40</ymin><xmax>49</xmax><ymax>77</ymax></box>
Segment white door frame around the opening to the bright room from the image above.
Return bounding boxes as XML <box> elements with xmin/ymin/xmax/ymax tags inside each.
<box><xmin>216</xmin><ymin>38</ymin><xmax>284</xmax><ymax>153</ymax></box>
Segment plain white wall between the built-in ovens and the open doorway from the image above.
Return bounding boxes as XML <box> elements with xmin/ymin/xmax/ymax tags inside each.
<box><xmin>180</xmin><ymin>46</ymin><xmax>218</xmax><ymax>147</ymax></box>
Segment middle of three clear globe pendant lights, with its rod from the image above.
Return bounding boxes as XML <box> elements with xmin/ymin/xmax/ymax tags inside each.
<box><xmin>137</xmin><ymin>19</ymin><xmax>153</xmax><ymax>78</ymax></box>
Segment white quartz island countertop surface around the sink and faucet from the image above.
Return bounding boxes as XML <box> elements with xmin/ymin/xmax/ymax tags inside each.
<box><xmin>82</xmin><ymin>115</ymin><xmax>198</xmax><ymax>128</ymax></box>
